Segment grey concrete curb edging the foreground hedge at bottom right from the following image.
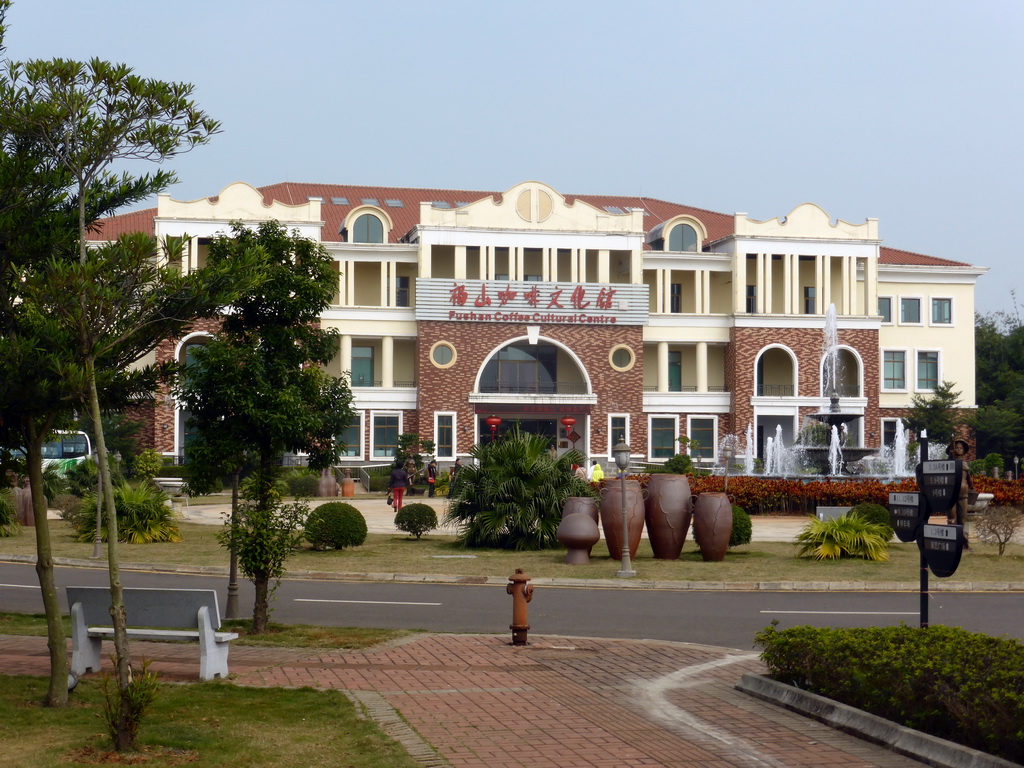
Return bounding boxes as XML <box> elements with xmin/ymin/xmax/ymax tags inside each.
<box><xmin>736</xmin><ymin>675</ymin><xmax>1019</xmax><ymax>768</ymax></box>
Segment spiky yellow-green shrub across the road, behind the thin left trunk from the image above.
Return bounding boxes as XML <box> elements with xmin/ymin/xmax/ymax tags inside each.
<box><xmin>72</xmin><ymin>482</ymin><xmax>181</xmax><ymax>544</ymax></box>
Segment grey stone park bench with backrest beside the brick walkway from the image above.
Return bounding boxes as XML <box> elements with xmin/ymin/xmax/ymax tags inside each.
<box><xmin>68</xmin><ymin>587</ymin><xmax>238</xmax><ymax>680</ymax></box>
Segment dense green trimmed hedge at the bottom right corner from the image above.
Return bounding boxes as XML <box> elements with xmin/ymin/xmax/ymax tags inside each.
<box><xmin>756</xmin><ymin>625</ymin><xmax>1024</xmax><ymax>762</ymax></box>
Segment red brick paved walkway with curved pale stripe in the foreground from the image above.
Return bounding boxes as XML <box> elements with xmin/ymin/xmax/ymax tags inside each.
<box><xmin>0</xmin><ymin>635</ymin><xmax>921</xmax><ymax>768</ymax></box>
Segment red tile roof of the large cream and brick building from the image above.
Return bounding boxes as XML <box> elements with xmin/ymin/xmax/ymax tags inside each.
<box><xmin>89</xmin><ymin>181</ymin><xmax>971</xmax><ymax>266</ymax></box>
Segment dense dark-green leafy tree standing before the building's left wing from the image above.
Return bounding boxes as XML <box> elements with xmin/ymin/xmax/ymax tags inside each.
<box><xmin>177</xmin><ymin>221</ymin><xmax>355</xmax><ymax>633</ymax></box>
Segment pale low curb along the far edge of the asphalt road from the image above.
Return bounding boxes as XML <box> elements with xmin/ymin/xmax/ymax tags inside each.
<box><xmin>0</xmin><ymin>554</ymin><xmax>1024</xmax><ymax>592</ymax></box>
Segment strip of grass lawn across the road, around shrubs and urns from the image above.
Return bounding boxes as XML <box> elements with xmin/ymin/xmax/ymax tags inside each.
<box><xmin>0</xmin><ymin>520</ymin><xmax>1024</xmax><ymax>584</ymax></box>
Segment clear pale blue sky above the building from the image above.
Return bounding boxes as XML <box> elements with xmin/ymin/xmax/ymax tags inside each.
<box><xmin>5</xmin><ymin>0</ymin><xmax>1024</xmax><ymax>316</ymax></box>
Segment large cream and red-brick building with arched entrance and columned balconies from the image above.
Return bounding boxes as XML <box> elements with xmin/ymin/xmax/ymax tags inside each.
<box><xmin>94</xmin><ymin>181</ymin><xmax>985</xmax><ymax>465</ymax></box>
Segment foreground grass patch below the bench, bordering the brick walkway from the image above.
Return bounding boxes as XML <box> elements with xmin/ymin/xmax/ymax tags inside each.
<box><xmin>0</xmin><ymin>675</ymin><xmax>419</xmax><ymax>768</ymax></box>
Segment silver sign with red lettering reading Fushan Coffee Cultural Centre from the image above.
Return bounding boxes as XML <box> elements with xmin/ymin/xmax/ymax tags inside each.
<box><xmin>416</xmin><ymin>278</ymin><xmax>649</xmax><ymax>326</ymax></box>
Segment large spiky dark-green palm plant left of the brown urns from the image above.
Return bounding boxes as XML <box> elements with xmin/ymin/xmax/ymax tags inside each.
<box><xmin>444</xmin><ymin>428</ymin><xmax>594</xmax><ymax>550</ymax></box>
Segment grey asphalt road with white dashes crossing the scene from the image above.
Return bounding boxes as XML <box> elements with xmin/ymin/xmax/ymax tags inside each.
<box><xmin>0</xmin><ymin>563</ymin><xmax>1024</xmax><ymax>649</ymax></box>
